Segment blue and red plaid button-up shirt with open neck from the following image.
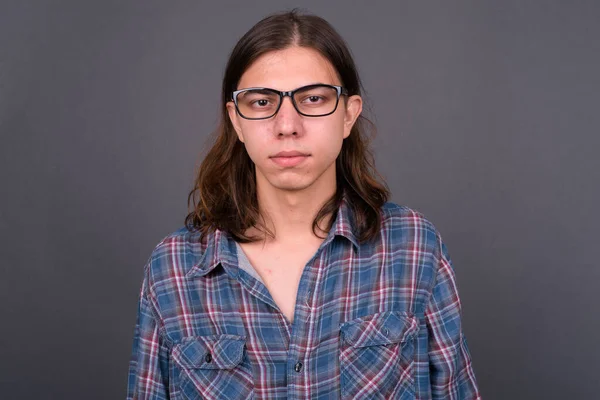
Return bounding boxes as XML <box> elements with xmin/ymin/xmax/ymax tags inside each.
<box><xmin>127</xmin><ymin>198</ymin><xmax>480</xmax><ymax>400</ymax></box>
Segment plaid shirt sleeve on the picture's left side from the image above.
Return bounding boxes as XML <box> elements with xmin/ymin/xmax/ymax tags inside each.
<box><xmin>127</xmin><ymin>266</ymin><xmax>169</xmax><ymax>400</ymax></box>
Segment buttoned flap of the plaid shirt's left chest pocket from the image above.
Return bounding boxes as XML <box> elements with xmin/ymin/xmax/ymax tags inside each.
<box><xmin>173</xmin><ymin>335</ymin><xmax>246</xmax><ymax>369</ymax></box>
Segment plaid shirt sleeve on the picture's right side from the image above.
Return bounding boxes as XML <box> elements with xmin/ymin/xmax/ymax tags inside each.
<box><xmin>425</xmin><ymin>234</ymin><xmax>481</xmax><ymax>400</ymax></box>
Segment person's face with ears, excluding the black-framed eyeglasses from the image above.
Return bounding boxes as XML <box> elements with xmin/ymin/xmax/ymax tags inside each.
<box><xmin>227</xmin><ymin>47</ymin><xmax>362</xmax><ymax>193</ymax></box>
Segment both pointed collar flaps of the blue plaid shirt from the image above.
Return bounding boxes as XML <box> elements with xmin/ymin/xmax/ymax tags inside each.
<box><xmin>186</xmin><ymin>195</ymin><xmax>358</xmax><ymax>278</ymax></box>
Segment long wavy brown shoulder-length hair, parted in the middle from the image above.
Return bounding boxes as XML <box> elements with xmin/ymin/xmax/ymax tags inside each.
<box><xmin>185</xmin><ymin>9</ymin><xmax>389</xmax><ymax>242</ymax></box>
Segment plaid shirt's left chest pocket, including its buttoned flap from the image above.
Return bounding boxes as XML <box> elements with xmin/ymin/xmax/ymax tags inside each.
<box><xmin>172</xmin><ymin>335</ymin><xmax>254</xmax><ymax>400</ymax></box>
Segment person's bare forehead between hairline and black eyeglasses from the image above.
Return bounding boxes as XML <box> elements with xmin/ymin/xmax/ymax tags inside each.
<box><xmin>238</xmin><ymin>47</ymin><xmax>341</xmax><ymax>90</ymax></box>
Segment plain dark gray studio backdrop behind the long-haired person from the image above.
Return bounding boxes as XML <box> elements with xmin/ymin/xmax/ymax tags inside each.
<box><xmin>0</xmin><ymin>0</ymin><xmax>600</xmax><ymax>400</ymax></box>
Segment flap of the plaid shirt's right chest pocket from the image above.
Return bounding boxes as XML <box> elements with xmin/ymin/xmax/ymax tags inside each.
<box><xmin>340</xmin><ymin>311</ymin><xmax>419</xmax><ymax>347</ymax></box>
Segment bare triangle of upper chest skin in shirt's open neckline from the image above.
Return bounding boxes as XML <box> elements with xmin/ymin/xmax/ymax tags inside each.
<box><xmin>240</xmin><ymin>239</ymin><xmax>322</xmax><ymax>323</ymax></box>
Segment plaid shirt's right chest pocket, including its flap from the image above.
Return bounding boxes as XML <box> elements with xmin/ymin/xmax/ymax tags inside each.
<box><xmin>340</xmin><ymin>311</ymin><xmax>419</xmax><ymax>400</ymax></box>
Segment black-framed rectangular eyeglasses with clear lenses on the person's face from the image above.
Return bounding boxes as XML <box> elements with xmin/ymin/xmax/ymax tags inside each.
<box><xmin>232</xmin><ymin>84</ymin><xmax>348</xmax><ymax>119</ymax></box>
